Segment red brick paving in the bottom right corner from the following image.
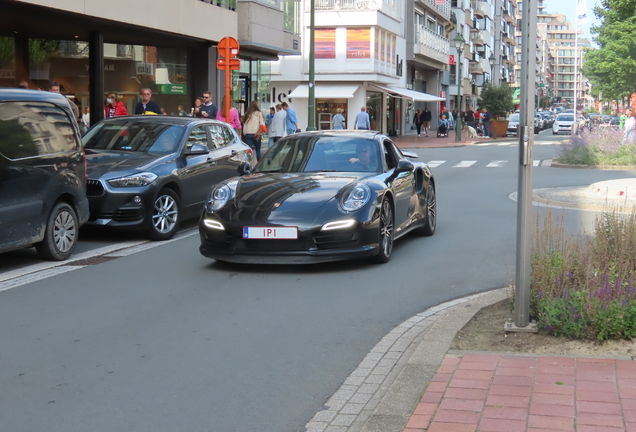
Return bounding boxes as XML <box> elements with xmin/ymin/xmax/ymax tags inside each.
<box><xmin>404</xmin><ymin>354</ymin><xmax>636</xmax><ymax>432</ymax></box>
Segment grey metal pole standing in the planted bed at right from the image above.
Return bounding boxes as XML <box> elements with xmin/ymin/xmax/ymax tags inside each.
<box><xmin>514</xmin><ymin>0</ymin><xmax>537</xmax><ymax>331</ymax></box>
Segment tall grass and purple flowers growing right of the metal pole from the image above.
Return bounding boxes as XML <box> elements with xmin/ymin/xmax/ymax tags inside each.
<box><xmin>530</xmin><ymin>211</ymin><xmax>636</xmax><ymax>341</ymax></box>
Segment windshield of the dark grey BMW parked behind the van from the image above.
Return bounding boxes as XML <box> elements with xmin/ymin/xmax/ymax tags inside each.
<box><xmin>82</xmin><ymin>119</ymin><xmax>185</xmax><ymax>154</ymax></box>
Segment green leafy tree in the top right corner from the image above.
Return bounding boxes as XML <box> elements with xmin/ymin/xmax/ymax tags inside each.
<box><xmin>583</xmin><ymin>0</ymin><xmax>636</xmax><ymax>100</ymax></box>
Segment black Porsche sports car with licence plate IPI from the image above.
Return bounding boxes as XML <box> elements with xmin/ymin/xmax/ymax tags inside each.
<box><xmin>199</xmin><ymin>131</ymin><xmax>437</xmax><ymax>264</ymax></box>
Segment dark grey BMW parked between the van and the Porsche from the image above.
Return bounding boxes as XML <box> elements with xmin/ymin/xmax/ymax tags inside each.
<box><xmin>83</xmin><ymin>116</ymin><xmax>253</xmax><ymax>240</ymax></box>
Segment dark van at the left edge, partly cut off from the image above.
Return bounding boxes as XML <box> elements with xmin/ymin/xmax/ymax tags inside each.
<box><xmin>0</xmin><ymin>89</ymin><xmax>88</xmax><ymax>261</ymax></box>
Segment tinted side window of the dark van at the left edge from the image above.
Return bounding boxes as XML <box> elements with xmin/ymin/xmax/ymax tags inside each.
<box><xmin>0</xmin><ymin>102</ymin><xmax>77</xmax><ymax>159</ymax></box>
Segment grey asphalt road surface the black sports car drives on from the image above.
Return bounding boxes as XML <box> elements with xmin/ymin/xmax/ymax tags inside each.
<box><xmin>0</xmin><ymin>132</ymin><xmax>631</xmax><ymax>432</ymax></box>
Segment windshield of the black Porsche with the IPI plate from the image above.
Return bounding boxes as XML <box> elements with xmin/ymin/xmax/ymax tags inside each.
<box><xmin>254</xmin><ymin>135</ymin><xmax>383</xmax><ymax>173</ymax></box>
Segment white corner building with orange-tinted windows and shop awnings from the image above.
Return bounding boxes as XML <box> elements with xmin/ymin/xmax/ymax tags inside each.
<box><xmin>271</xmin><ymin>0</ymin><xmax>453</xmax><ymax>136</ymax></box>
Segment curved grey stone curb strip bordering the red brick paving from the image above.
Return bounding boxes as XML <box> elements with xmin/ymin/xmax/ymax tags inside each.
<box><xmin>306</xmin><ymin>288</ymin><xmax>510</xmax><ymax>432</ymax></box>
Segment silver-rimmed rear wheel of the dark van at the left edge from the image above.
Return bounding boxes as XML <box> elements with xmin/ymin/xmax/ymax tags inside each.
<box><xmin>35</xmin><ymin>202</ymin><xmax>79</xmax><ymax>261</ymax></box>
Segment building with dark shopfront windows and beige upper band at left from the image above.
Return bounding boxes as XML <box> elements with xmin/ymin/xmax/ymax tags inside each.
<box><xmin>0</xmin><ymin>0</ymin><xmax>301</xmax><ymax>122</ymax></box>
